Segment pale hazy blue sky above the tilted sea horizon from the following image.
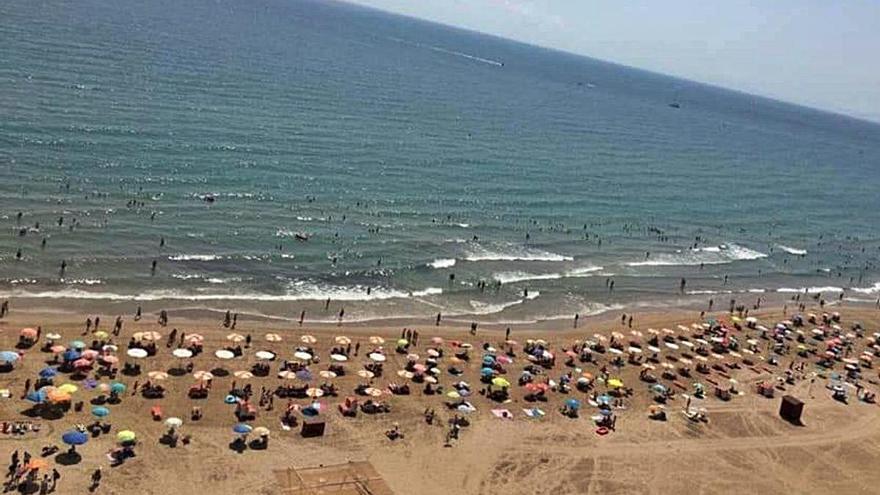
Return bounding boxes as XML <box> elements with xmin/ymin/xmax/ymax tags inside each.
<box><xmin>347</xmin><ymin>0</ymin><xmax>880</xmax><ymax>122</ymax></box>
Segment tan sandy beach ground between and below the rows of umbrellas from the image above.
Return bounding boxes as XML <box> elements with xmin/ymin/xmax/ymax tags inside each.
<box><xmin>0</xmin><ymin>300</ymin><xmax>880</xmax><ymax>494</ymax></box>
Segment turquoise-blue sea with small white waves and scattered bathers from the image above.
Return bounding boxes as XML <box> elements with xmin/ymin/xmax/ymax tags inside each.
<box><xmin>0</xmin><ymin>0</ymin><xmax>880</xmax><ymax>321</ymax></box>
